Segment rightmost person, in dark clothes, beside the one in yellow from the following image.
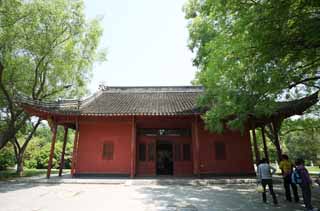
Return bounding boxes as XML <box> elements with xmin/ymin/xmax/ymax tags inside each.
<box><xmin>295</xmin><ymin>159</ymin><xmax>318</xmax><ymax>211</ymax></box>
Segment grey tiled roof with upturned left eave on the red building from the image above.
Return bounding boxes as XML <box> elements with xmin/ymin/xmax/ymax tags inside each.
<box><xmin>17</xmin><ymin>86</ymin><xmax>203</xmax><ymax>116</ymax></box>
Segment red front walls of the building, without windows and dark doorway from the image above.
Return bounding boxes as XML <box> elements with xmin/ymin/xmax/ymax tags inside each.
<box><xmin>75</xmin><ymin>117</ymin><xmax>254</xmax><ymax>175</ymax></box>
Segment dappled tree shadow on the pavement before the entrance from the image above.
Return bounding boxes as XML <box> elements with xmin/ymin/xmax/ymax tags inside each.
<box><xmin>137</xmin><ymin>182</ymin><xmax>316</xmax><ymax>211</ymax></box>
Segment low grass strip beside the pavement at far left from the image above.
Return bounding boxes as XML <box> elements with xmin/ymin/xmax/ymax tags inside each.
<box><xmin>0</xmin><ymin>169</ymin><xmax>59</xmax><ymax>181</ymax></box>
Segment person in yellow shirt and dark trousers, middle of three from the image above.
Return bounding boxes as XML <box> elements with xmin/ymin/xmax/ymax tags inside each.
<box><xmin>279</xmin><ymin>154</ymin><xmax>299</xmax><ymax>202</ymax></box>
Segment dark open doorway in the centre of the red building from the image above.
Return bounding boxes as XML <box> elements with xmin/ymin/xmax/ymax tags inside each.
<box><xmin>157</xmin><ymin>141</ymin><xmax>173</xmax><ymax>175</ymax></box>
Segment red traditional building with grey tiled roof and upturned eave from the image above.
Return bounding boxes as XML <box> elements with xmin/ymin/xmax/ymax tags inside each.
<box><xmin>21</xmin><ymin>86</ymin><xmax>254</xmax><ymax>177</ymax></box>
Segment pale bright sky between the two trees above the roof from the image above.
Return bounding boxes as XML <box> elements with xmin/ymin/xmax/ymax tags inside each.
<box><xmin>85</xmin><ymin>0</ymin><xmax>196</xmax><ymax>92</ymax></box>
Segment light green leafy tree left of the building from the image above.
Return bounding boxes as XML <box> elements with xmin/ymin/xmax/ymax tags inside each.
<box><xmin>0</xmin><ymin>0</ymin><xmax>104</xmax><ymax>173</ymax></box>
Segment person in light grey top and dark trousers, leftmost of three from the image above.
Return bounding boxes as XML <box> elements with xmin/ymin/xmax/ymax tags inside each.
<box><xmin>258</xmin><ymin>158</ymin><xmax>278</xmax><ymax>205</ymax></box>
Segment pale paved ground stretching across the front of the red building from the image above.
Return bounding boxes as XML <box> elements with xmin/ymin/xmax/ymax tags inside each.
<box><xmin>0</xmin><ymin>177</ymin><xmax>320</xmax><ymax>211</ymax></box>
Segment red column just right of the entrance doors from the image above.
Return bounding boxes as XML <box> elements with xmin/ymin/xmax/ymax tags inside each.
<box><xmin>192</xmin><ymin>116</ymin><xmax>200</xmax><ymax>175</ymax></box>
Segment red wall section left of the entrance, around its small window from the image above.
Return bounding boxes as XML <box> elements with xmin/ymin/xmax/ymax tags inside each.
<box><xmin>76</xmin><ymin>119</ymin><xmax>132</xmax><ymax>174</ymax></box>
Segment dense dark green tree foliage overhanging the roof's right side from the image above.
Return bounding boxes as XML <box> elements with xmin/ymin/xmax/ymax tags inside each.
<box><xmin>184</xmin><ymin>0</ymin><xmax>320</xmax><ymax>131</ymax></box>
